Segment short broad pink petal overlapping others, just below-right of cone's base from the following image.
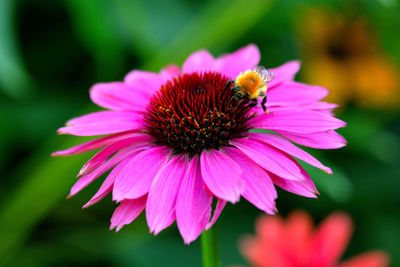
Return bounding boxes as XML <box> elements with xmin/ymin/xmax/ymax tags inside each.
<box><xmin>200</xmin><ymin>150</ymin><xmax>244</xmax><ymax>203</ymax></box>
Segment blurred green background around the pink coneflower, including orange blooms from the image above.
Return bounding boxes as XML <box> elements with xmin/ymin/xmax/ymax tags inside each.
<box><xmin>0</xmin><ymin>0</ymin><xmax>400</xmax><ymax>266</ymax></box>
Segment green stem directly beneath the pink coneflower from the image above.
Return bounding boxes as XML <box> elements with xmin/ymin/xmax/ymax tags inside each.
<box><xmin>201</xmin><ymin>224</ymin><xmax>221</xmax><ymax>267</ymax></box>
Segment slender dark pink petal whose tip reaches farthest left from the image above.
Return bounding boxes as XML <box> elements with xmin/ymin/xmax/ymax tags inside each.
<box><xmin>51</xmin><ymin>133</ymin><xmax>134</xmax><ymax>156</ymax></box>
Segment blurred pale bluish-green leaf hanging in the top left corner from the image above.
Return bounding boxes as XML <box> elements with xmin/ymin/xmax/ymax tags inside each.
<box><xmin>0</xmin><ymin>0</ymin><xmax>32</xmax><ymax>99</ymax></box>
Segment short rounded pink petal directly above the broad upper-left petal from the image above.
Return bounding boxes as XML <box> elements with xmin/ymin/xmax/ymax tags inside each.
<box><xmin>124</xmin><ymin>70</ymin><xmax>164</xmax><ymax>96</ymax></box>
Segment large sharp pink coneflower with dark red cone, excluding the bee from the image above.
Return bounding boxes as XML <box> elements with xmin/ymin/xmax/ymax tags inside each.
<box><xmin>54</xmin><ymin>45</ymin><xmax>345</xmax><ymax>243</ymax></box>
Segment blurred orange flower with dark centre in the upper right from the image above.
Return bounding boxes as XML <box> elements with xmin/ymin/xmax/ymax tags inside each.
<box><xmin>298</xmin><ymin>9</ymin><xmax>400</xmax><ymax>109</ymax></box>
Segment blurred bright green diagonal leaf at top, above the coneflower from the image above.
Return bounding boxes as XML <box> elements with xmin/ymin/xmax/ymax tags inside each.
<box><xmin>145</xmin><ymin>0</ymin><xmax>272</xmax><ymax>70</ymax></box>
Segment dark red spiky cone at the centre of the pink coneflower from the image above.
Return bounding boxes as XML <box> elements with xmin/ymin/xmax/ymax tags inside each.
<box><xmin>144</xmin><ymin>72</ymin><xmax>252</xmax><ymax>157</ymax></box>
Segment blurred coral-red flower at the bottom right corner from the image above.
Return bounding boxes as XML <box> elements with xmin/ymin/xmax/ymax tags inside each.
<box><xmin>241</xmin><ymin>211</ymin><xmax>389</xmax><ymax>267</ymax></box>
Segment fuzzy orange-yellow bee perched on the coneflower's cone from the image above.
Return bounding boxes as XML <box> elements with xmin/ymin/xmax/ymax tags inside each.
<box><xmin>225</xmin><ymin>66</ymin><xmax>275</xmax><ymax>113</ymax></box>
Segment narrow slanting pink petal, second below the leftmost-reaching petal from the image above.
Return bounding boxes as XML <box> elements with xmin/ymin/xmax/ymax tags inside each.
<box><xmin>68</xmin><ymin>147</ymin><xmax>144</xmax><ymax>197</ymax></box>
